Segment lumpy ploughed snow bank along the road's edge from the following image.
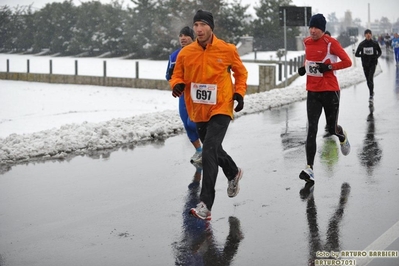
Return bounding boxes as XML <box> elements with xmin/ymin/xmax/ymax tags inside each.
<box><xmin>0</xmin><ymin>59</ymin><xmax>381</xmax><ymax>164</ymax></box>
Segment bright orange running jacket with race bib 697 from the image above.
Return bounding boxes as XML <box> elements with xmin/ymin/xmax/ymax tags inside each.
<box><xmin>169</xmin><ymin>35</ymin><xmax>248</xmax><ymax>122</ymax></box>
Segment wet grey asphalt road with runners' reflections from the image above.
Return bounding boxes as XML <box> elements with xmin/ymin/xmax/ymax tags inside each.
<box><xmin>0</xmin><ymin>56</ymin><xmax>399</xmax><ymax>266</ymax></box>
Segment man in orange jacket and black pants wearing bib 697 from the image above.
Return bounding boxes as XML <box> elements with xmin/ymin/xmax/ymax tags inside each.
<box><xmin>169</xmin><ymin>10</ymin><xmax>248</xmax><ymax>220</ymax></box>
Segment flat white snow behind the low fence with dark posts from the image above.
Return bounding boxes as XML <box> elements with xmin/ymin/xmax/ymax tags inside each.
<box><xmin>0</xmin><ymin>51</ymin><xmax>304</xmax><ymax>85</ymax></box>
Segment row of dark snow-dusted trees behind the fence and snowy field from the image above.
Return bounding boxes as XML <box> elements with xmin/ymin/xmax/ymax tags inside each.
<box><xmin>0</xmin><ymin>0</ymin><xmax>396</xmax><ymax>59</ymax></box>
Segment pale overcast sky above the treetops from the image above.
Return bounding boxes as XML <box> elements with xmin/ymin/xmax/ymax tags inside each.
<box><xmin>0</xmin><ymin>0</ymin><xmax>399</xmax><ymax>26</ymax></box>
